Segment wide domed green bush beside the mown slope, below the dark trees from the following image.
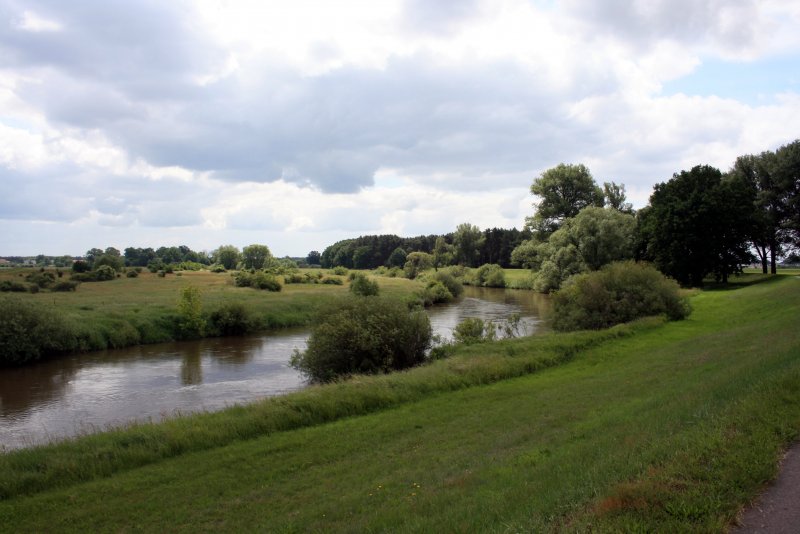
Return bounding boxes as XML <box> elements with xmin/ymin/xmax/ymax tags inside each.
<box><xmin>552</xmin><ymin>261</ymin><xmax>691</xmax><ymax>331</ymax></box>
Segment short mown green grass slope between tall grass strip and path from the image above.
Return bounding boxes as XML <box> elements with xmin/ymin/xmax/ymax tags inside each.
<box><xmin>0</xmin><ymin>277</ymin><xmax>800</xmax><ymax>531</ymax></box>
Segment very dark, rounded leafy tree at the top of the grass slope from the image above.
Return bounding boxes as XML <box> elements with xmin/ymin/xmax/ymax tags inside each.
<box><xmin>639</xmin><ymin>165</ymin><xmax>752</xmax><ymax>286</ymax></box>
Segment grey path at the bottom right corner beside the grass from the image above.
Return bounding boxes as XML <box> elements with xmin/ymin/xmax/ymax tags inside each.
<box><xmin>730</xmin><ymin>444</ymin><xmax>800</xmax><ymax>534</ymax></box>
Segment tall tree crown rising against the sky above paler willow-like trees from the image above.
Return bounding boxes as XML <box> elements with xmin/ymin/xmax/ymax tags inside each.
<box><xmin>526</xmin><ymin>163</ymin><xmax>604</xmax><ymax>236</ymax></box>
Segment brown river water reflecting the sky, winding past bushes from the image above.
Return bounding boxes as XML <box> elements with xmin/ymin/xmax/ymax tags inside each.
<box><xmin>0</xmin><ymin>287</ymin><xmax>547</xmax><ymax>451</ymax></box>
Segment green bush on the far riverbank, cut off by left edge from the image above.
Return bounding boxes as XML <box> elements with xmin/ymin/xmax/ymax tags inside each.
<box><xmin>0</xmin><ymin>298</ymin><xmax>78</xmax><ymax>365</ymax></box>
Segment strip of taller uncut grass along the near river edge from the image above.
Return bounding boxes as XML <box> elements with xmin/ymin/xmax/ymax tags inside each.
<box><xmin>0</xmin><ymin>319</ymin><xmax>661</xmax><ymax>499</ymax></box>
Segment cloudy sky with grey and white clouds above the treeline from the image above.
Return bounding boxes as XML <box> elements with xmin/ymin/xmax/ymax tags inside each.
<box><xmin>0</xmin><ymin>0</ymin><xmax>800</xmax><ymax>256</ymax></box>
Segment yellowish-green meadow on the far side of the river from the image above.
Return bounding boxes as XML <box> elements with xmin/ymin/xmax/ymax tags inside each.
<box><xmin>0</xmin><ymin>269</ymin><xmax>419</xmax><ymax>365</ymax></box>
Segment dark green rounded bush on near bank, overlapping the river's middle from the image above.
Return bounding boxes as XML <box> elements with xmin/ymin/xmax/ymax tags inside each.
<box><xmin>291</xmin><ymin>297</ymin><xmax>432</xmax><ymax>382</ymax></box>
